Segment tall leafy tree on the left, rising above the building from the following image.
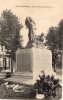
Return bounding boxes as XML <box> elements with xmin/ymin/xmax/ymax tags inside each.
<box><xmin>0</xmin><ymin>9</ymin><xmax>23</xmax><ymax>72</ymax></box>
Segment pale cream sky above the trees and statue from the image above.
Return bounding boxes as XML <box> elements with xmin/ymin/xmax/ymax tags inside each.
<box><xmin>0</xmin><ymin>0</ymin><xmax>63</xmax><ymax>45</ymax></box>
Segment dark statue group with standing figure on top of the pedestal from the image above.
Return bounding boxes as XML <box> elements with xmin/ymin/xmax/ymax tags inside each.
<box><xmin>25</xmin><ymin>17</ymin><xmax>45</xmax><ymax>48</ymax></box>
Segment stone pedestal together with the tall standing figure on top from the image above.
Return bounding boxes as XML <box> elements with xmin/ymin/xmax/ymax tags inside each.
<box><xmin>16</xmin><ymin>17</ymin><xmax>53</xmax><ymax>82</ymax></box>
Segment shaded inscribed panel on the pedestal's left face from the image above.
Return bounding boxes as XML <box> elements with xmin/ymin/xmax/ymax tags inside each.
<box><xmin>17</xmin><ymin>53</ymin><xmax>32</xmax><ymax>72</ymax></box>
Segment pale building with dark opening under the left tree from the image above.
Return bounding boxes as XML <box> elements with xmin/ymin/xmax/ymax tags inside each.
<box><xmin>0</xmin><ymin>45</ymin><xmax>11</xmax><ymax>71</ymax></box>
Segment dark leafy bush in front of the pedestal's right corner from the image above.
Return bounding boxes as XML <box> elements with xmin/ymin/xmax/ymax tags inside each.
<box><xmin>34</xmin><ymin>73</ymin><xmax>59</xmax><ymax>97</ymax></box>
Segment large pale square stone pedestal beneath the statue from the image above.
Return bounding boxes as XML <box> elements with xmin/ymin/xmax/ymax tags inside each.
<box><xmin>16</xmin><ymin>47</ymin><xmax>52</xmax><ymax>81</ymax></box>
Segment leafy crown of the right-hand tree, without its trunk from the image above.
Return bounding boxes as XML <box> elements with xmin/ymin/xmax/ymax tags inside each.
<box><xmin>46</xmin><ymin>19</ymin><xmax>63</xmax><ymax>51</ymax></box>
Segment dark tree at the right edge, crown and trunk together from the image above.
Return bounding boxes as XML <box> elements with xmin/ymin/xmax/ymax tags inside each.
<box><xmin>46</xmin><ymin>20</ymin><xmax>63</xmax><ymax>68</ymax></box>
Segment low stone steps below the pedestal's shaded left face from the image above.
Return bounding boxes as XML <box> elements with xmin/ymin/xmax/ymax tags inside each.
<box><xmin>5</xmin><ymin>72</ymin><xmax>33</xmax><ymax>85</ymax></box>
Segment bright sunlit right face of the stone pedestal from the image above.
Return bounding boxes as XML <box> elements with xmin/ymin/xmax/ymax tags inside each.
<box><xmin>33</xmin><ymin>48</ymin><xmax>53</xmax><ymax>82</ymax></box>
